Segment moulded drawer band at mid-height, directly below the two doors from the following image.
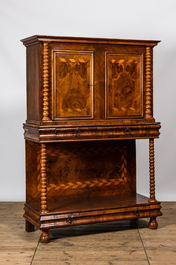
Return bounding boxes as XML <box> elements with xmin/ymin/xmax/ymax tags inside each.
<box><xmin>24</xmin><ymin>124</ymin><xmax>161</xmax><ymax>142</ymax></box>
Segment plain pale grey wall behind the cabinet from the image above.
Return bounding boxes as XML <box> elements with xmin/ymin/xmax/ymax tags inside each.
<box><xmin>0</xmin><ymin>0</ymin><xmax>176</xmax><ymax>201</ymax></box>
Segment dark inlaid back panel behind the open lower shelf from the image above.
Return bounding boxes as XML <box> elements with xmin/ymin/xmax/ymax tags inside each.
<box><xmin>47</xmin><ymin>140</ymin><xmax>136</xmax><ymax>201</ymax></box>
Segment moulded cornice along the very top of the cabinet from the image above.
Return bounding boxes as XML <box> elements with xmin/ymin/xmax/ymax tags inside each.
<box><xmin>21</xmin><ymin>35</ymin><xmax>160</xmax><ymax>46</ymax></box>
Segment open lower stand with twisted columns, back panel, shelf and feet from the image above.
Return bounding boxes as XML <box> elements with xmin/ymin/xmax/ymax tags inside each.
<box><xmin>24</xmin><ymin>139</ymin><xmax>162</xmax><ymax>242</ymax></box>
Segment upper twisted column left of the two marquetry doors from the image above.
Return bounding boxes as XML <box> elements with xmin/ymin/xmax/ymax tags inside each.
<box><xmin>42</xmin><ymin>43</ymin><xmax>50</xmax><ymax>121</ymax></box>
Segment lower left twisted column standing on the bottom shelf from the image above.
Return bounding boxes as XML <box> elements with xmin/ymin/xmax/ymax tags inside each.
<box><xmin>40</xmin><ymin>144</ymin><xmax>47</xmax><ymax>213</ymax></box>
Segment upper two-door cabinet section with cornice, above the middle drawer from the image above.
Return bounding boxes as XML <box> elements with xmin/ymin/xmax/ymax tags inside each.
<box><xmin>22</xmin><ymin>36</ymin><xmax>158</xmax><ymax>125</ymax></box>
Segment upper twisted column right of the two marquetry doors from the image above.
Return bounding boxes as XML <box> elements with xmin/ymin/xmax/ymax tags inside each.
<box><xmin>145</xmin><ymin>47</ymin><xmax>153</xmax><ymax>120</ymax></box>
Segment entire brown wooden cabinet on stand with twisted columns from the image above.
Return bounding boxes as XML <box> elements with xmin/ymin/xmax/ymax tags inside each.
<box><xmin>22</xmin><ymin>36</ymin><xmax>162</xmax><ymax>242</ymax></box>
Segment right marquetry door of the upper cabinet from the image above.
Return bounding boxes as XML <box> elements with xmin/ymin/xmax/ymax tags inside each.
<box><xmin>106</xmin><ymin>52</ymin><xmax>143</xmax><ymax>118</ymax></box>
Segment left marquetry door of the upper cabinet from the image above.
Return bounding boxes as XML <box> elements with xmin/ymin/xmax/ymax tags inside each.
<box><xmin>52</xmin><ymin>50</ymin><xmax>94</xmax><ymax>119</ymax></box>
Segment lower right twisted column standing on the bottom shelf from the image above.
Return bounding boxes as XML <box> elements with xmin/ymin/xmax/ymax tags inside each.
<box><xmin>149</xmin><ymin>139</ymin><xmax>156</xmax><ymax>202</ymax></box>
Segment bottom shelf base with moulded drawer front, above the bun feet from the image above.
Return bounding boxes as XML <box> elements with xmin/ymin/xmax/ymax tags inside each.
<box><xmin>24</xmin><ymin>193</ymin><xmax>162</xmax><ymax>229</ymax></box>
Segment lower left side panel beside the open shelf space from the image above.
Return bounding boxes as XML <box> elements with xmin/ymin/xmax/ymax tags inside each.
<box><xmin>26</xmin><ymin>141</ymin><xmax>40</xmax><ymax>203</ymax></box>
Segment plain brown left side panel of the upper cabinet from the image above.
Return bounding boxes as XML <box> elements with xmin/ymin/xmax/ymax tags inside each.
<box><xmin>27</xmin><ymin>44</ymin><xmax>41</xmax><ymax>121</ymax></box>
